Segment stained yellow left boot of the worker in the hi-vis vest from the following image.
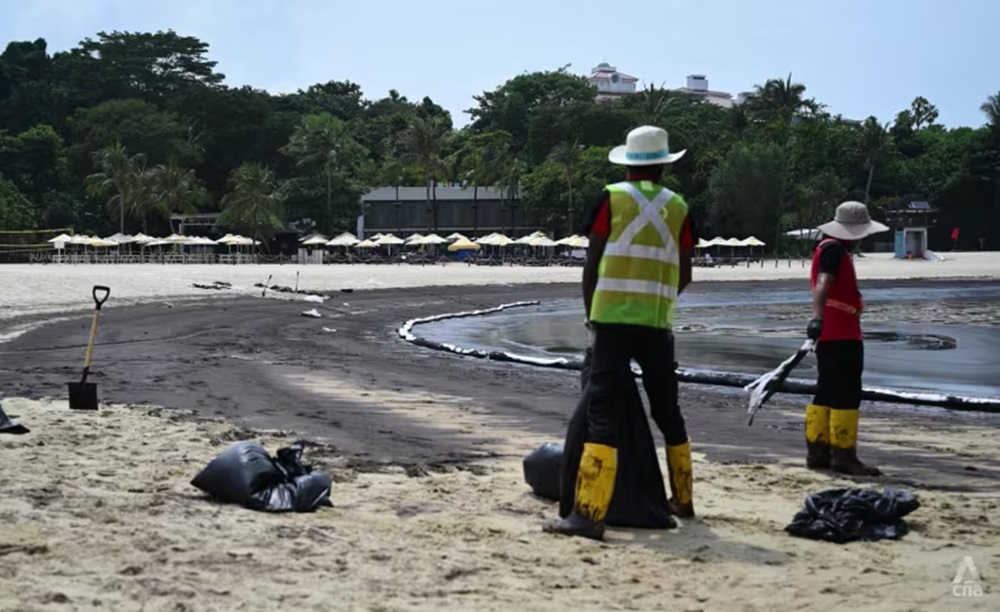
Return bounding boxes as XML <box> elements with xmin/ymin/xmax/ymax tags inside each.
<box><xmin>542</xmin><ymin>442</ymin><xmax>618</xmax><ymax>540</ymax></box>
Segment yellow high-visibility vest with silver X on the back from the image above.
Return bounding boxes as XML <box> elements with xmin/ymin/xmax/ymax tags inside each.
<box><xmin>589</xmin><ymin>181</ymin><xmax>688</xmax><ymax>329</ymax></box>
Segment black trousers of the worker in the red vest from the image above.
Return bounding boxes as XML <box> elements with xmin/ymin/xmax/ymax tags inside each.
<box><xmin>813</xmin><ymin>340</ymin><xmax>865</xmax><ymax>410</ymax></box>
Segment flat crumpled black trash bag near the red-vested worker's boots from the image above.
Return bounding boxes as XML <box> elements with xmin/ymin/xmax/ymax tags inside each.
<box><xmin>785</xmin><ymin>487</ymin><xmax>920</xmax><ymax>544</ymax></box>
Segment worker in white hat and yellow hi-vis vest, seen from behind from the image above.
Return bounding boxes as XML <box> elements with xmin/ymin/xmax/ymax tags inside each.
<box><xmin>544</xmin><ymin>126</ymin><xmax>695</xmax><ymax>540</ymax></box>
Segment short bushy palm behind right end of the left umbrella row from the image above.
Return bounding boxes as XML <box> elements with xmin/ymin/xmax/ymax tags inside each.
<box><xmin>219</xmin><ymin>163</ymin><xmax>285</xmax><ymax>251</ymax></box>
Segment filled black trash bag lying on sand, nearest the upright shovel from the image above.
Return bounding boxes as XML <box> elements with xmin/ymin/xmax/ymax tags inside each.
<box><xmin>191</xmin><ymin>441</ymin><xmax>332</xmax><ymax>512</ymax></box>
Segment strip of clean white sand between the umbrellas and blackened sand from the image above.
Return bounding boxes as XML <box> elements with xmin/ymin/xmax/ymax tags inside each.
<box><xmin>0</xmin><ymin>253</ymin><xmax>1000</xmax><ymax>319</ymax></box>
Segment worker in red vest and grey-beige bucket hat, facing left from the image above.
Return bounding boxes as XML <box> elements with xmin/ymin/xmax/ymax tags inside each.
<box><xmin>806</xmin><ymin>202</ymin><xmax>889</xmax><ymax>476</ymax></box>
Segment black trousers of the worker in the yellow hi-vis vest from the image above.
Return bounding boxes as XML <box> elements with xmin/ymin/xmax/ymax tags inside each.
<box><xmin>587</xmin><ymin>324</ymin><xmax>687</xmax><ymax>448</ymax></box>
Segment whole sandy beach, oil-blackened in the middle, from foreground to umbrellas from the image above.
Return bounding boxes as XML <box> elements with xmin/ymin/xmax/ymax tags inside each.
<box><xmin>0</xmin><ymin>262</ymin><xmax>1000</xmax><ymax>610</ymax></box>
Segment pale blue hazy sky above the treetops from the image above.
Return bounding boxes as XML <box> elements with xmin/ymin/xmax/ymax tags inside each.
<box><xmin>0</xmin><ymin>0</ymin><xmax>1000</xmax><ymax>126</ymax></box>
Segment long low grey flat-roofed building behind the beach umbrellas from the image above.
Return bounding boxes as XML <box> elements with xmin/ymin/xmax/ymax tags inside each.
<box><xmin>357</xmin><ymin>185</ymin><xmax>539</xmax><ymax>238</ymax></box>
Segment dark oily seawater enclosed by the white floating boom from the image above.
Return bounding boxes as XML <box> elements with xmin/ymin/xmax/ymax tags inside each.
<box><xmin>420</xmin><ymin>281</ymin><xmax>1000</xmax><ymax>397</ymax></box>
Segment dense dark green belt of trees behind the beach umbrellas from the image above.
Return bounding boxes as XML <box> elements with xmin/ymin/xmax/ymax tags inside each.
<box><xmin>0</xmin><ymin>31</ymin><xmax>1000</xmax><ymax>249</ymax></box>
